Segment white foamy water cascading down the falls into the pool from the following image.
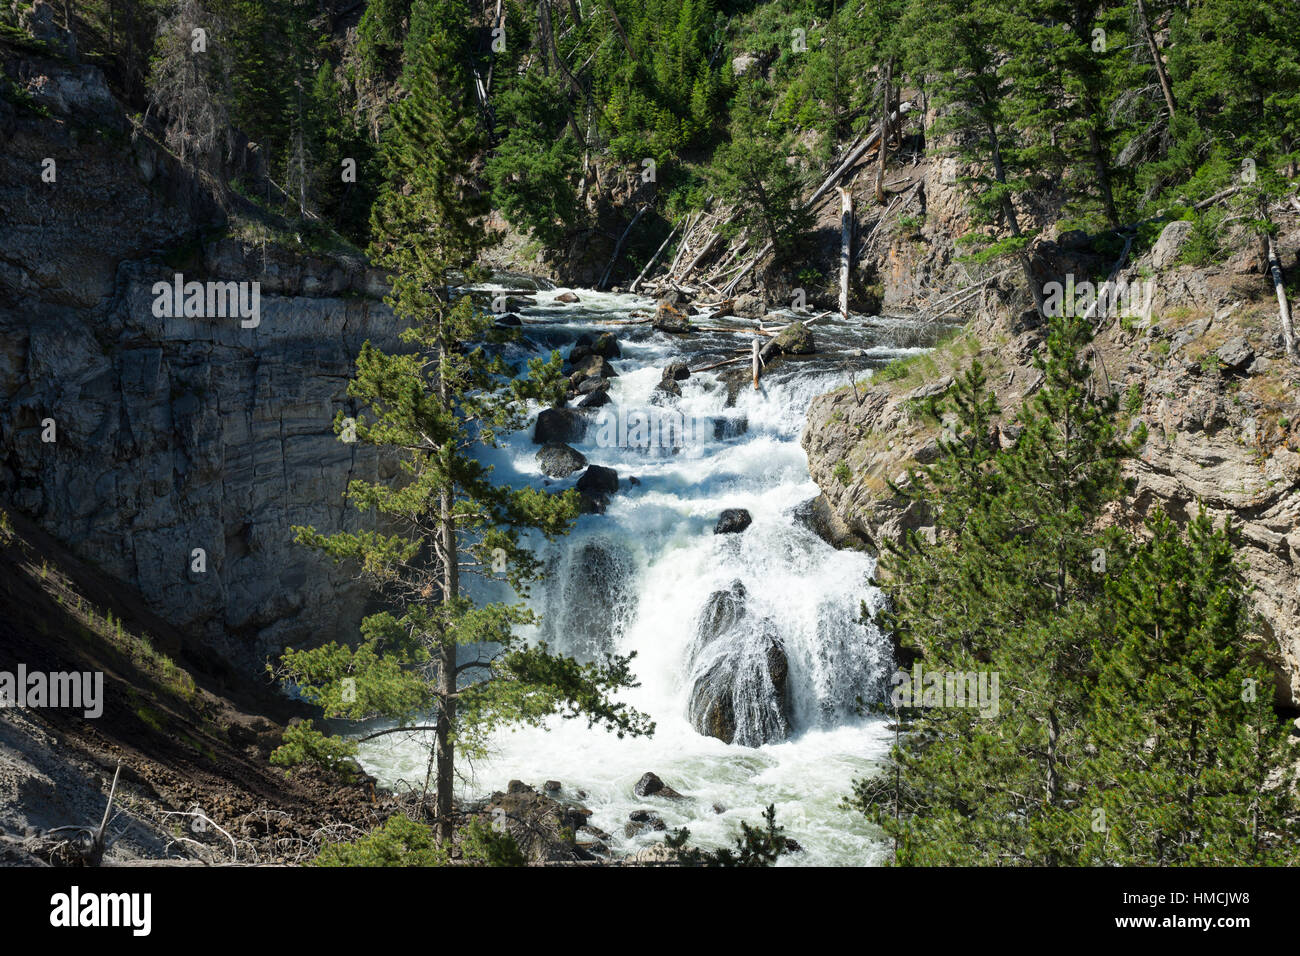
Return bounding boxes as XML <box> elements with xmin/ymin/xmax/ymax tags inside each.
<box><xmin>363</xmin><ymin>289</ymin><xmax>935</xmax><ymax>865</ymax></box>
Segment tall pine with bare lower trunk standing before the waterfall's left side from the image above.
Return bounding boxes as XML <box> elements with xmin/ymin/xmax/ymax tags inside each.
<box><xmin>278</xmin><ymin>0</ymin><xmax>653</xmax><ymax>843</ymax></box>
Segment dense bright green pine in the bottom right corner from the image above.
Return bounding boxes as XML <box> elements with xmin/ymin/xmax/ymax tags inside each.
<box><xmin>1078</xmin><ymin>509</ymin><xmax>1296</xmax><ymax>866</ymax></box>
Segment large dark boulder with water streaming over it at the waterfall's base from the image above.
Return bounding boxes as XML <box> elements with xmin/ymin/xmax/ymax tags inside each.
<box><xmin>688</xmin><ymin>581</ymin><xmax>790</xmax><ymax>747</ymax></box>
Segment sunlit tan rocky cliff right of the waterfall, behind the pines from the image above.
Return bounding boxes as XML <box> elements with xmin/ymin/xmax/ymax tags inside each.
<box><xmin>803</xmin><ymin>216</ymin><xmax>1300</xmax><ymax>708</ymax></box>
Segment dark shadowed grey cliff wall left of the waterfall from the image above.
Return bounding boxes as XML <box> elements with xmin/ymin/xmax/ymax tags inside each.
<box><xmin>0</xmin><ymin>46</ymin><xmax>397</xmax><ymax>675</ymax></box>
